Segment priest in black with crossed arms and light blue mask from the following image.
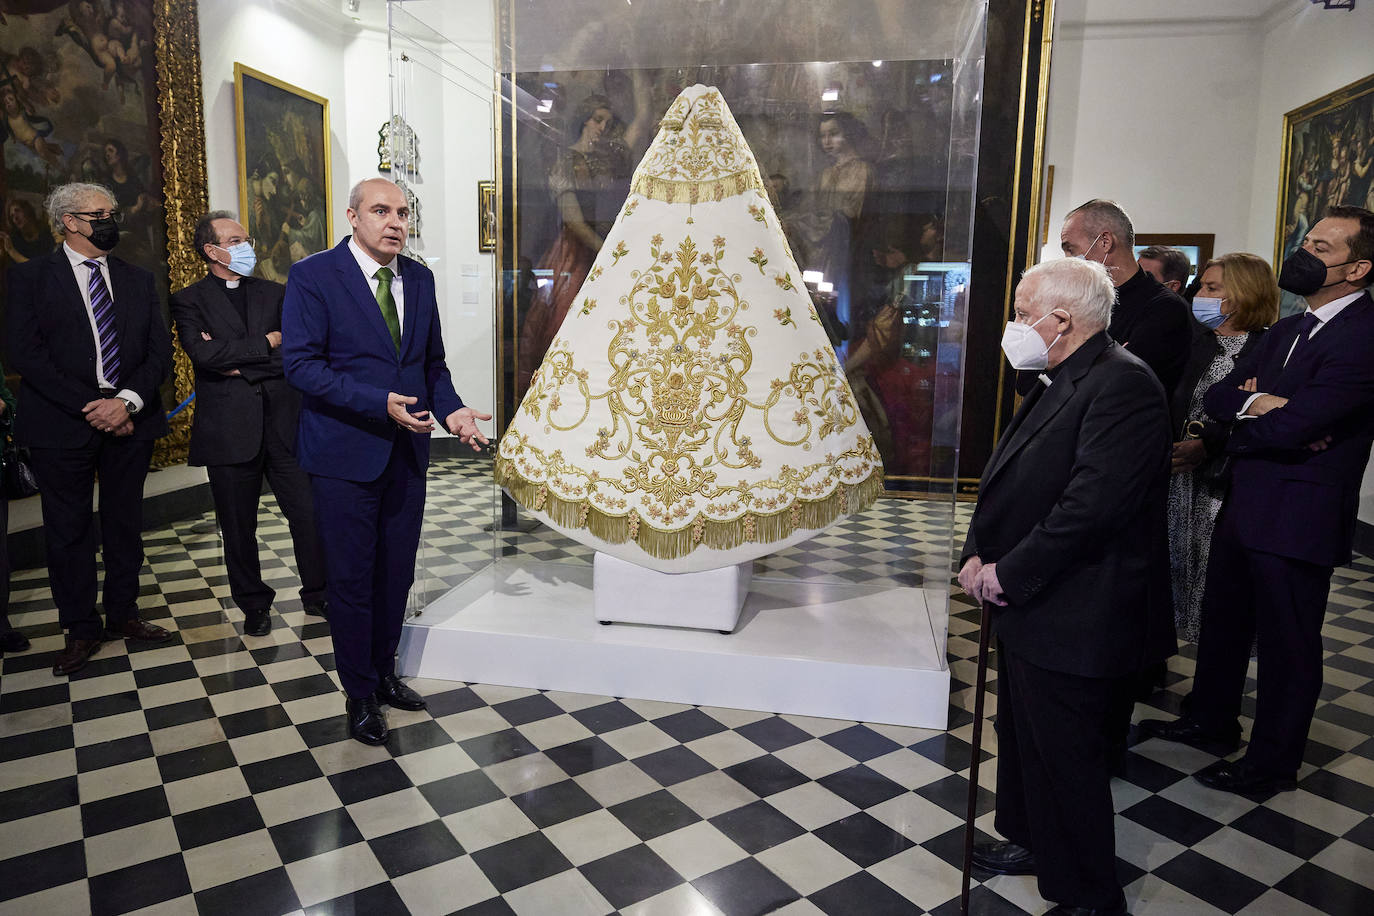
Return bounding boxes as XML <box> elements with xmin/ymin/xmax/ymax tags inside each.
<box><xmin>172</xmin><ymin>210</ymin><xmax>324</xmax><ymax>636</ymax></box>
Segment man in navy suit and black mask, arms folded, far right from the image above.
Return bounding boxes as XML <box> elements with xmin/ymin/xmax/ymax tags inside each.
<box><xmin>1140</xmin><ymin>207</ymin><xmax>1374</xmax><ymax>798</ymax></box>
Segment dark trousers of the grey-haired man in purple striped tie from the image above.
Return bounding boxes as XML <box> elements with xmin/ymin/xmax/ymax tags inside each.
<box><xmin>29</xmin><ymin>435</ymin><xmax>153</xmax><ymax>640</ymax></box>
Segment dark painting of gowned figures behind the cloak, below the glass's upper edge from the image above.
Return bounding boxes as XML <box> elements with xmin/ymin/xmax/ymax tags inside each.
<box><xmin>502</xmin><ymin>60</ymin><xmax>967</xmax><ymax>488</ymax></box>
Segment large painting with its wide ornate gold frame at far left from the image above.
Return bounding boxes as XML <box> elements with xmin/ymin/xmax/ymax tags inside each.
<box><xmin>0</xmin><ymin>0</ymin><xmax>207</xmax><ymax>467</ymax></box>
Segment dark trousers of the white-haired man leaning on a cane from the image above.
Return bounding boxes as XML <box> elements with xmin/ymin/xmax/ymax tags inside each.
<box><xmin>995</xmin><ymin>645</ymin><xmax>1128</xmax><ymax>908</ymax></box>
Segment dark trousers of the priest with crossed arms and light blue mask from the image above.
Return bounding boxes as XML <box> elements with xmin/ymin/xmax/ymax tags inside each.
<box><xmin>206</xmin><ymin>414</ymin><xmax>324</xmax><ymax>614</ymax></box>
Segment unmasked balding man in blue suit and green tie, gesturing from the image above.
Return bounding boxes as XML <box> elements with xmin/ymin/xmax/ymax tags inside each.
<box><xmin>282</xmin><ymin>179</ymin><xmax>492</xmax><ymax>744</ymax></box>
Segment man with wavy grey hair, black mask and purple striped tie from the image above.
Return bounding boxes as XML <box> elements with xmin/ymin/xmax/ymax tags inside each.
<box><xmin>7</xmin><ymin>184</ymin><xmax>172</xmax><ymax>676</ymax></box>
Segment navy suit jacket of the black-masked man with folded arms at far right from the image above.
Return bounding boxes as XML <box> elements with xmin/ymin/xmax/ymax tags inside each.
<box><xmin>1204</xmin><ymin>291</ymin><xmax>1374</xmax><ymax>566</ymax></box>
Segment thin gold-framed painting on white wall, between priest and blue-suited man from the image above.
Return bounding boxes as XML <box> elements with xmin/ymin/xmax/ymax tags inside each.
<box><xmin>234</xmin><ymin>63</ymin><xmax>334</xmax><ymax>283</ymax></box>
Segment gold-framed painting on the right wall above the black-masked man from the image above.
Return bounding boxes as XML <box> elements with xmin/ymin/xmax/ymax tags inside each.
<box><xmin>1274</xmin><ymin>73</ymin><xmax>1374</xmax><ymax>314</ymax></box>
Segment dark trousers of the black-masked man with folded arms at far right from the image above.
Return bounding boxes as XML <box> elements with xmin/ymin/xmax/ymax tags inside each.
<box><xmin>1189</xmin><ymin>508</ymin><xmax>1333</xmax><ymax>777</ymax></box>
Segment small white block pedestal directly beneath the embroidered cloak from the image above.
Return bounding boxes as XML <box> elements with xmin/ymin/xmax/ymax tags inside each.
<box><xmin>592</xmin><ymin>551</ymin><xmax>754</xmax><ymax>633</ymax></box>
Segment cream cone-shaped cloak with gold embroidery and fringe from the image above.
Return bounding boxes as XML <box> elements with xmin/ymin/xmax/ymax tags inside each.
<box><xmin>496</xmin><ymin>85</ymin><xmax>882</xmax><ymax>573</ymax></box>
